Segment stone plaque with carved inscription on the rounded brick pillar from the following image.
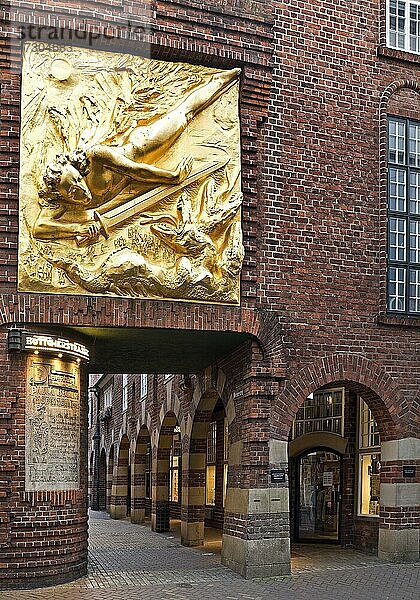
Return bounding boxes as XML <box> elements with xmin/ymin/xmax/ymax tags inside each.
<box><xmin>25</xmin><ymin>356</ymin><xmax>80</xmax><ymax>491</ymax></box>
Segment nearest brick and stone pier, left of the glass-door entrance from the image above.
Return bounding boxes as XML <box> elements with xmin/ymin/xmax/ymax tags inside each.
<box><xmin>222</xmin><ymin>379</ymin><xmax>290</xmax><ymax>578</ymax></box>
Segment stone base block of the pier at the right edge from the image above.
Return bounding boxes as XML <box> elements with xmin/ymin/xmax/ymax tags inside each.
<box><xmin>378</xmin><ymin>529</ymin><xmax>420</xmax><ymax>562</ymax></box>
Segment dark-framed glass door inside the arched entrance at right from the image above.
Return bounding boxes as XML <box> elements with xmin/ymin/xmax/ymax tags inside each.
<box><xmin>297</xmin><ymin>450</ymin><xmax>341</xmax><ymax>542</ymax></box>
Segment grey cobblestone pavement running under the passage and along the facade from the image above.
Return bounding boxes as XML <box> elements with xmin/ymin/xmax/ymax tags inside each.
<box><xmin>0</xmin><ymin>513</ymin><xmax>420</xmax><ymax>600</ymax></box>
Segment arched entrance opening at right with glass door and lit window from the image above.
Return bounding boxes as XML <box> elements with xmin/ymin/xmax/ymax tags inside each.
<box><xmin>289</xmin><ymin>380</ymin><xmax>396</xmax><ymax>553</ymax></box>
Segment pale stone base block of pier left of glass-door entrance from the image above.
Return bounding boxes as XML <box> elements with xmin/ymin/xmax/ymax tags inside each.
<box><xmin>222</xmin><ymin>534</ymin><xmax>291</xmax><ymax>579</ymax></box>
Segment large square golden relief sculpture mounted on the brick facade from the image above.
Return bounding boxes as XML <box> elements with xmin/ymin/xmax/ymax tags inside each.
<box><xmin>19</xmin><ymin>42</ymin><xmax>244</xmax><ymax>304</ymax></box>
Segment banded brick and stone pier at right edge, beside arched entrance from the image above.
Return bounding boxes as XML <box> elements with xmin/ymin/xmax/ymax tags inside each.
<box><xmin>378</xmin><ymin>438</ymin><xmax>420</xmax><ymax>562</ymax></box>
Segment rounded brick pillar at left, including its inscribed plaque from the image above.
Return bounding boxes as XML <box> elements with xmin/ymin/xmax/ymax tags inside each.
<box><xmin>0</xmin><ymin>329</ymin><xmax>87</xmax><ymax>589</ymax></box>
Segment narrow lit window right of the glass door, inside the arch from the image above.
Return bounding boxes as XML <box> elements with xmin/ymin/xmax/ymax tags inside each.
<box><xmin>358</xmin><ymin>398</ymin><xmax>381</xmax><ymax>516</ymax></box>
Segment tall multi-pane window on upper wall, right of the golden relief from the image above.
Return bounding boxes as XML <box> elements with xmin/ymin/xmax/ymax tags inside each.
<box><xmin>388</xmin><ymin>117</ymin><xmax>420</xmax><ymax>315</ymax></box>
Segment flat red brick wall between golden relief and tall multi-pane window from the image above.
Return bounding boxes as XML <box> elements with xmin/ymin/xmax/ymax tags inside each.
<box><xmin>257</xmin><ymin>0</ymin><xmax>419</xmax><ymax>431</ymax></box>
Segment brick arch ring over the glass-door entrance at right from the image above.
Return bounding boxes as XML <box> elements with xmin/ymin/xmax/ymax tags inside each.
<box><xmin>276</xmin><ymin>353</ymin><xmax>403</xmax><ymax>440</ymax></box>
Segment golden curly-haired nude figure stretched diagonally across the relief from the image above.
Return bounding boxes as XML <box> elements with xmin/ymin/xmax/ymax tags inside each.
<box><xmin>32</xmin><ymin>69</ymin><xmax>240</xmax><ymax>245</ymax></box>
